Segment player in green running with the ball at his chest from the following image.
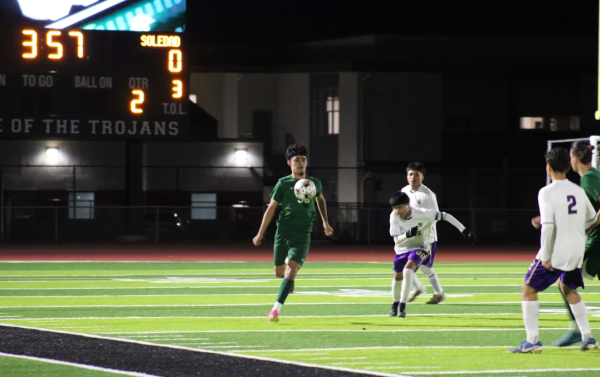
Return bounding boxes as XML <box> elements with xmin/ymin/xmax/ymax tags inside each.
<box><xmin>252</xmin><ymin>143</ymin><xmax>333</xmax><ymax>322</ymax></box>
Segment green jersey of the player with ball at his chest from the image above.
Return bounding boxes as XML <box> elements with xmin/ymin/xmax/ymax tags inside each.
<box><xmin>271</xmin><ymin>175</ymin><xmax>323</xmax><ymax>233</ymax></box>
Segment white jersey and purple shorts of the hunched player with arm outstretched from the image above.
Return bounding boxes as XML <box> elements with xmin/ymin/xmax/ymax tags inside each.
<box><xmin>390</xmin><ymin>207</ymin><xmax>465</xmax><ymax>272</ymax></box>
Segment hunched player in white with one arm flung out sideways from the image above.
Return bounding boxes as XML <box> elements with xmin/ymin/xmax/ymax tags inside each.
<box><xmin>390</xmin><ymin>191</ymin><xmax>473</xmax><ymax>318</ymax></box>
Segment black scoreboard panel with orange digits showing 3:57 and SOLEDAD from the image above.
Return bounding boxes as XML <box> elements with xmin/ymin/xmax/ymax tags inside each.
<box><xmin>0</xmin><ymin>27</ymin><xmax>189</xmax><ymax>139</ymax></box>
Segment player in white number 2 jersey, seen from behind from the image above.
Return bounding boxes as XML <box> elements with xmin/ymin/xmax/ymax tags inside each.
<box><xmin>508</xmin><ymin>148</ymin><xmax>598</xmax><ymax>353</ymax></box>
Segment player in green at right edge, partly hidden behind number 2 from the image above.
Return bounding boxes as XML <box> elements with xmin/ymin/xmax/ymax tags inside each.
<box><xmin>533</xmin><ymin>140</ymin><xmax>600</xmax><ymax>347</ymax></box>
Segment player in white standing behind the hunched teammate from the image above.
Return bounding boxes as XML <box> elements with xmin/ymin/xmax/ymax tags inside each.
<box><xmin>402</xmin><ymin>162</ymin><xmax>446</xmax><ymax>304</ymax></box>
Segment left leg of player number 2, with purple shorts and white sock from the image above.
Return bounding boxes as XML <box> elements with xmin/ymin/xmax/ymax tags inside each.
<box><xmin>508</xmin><ymin>260</ymin><xmax>561</xmax><ymax>353</ymax></box>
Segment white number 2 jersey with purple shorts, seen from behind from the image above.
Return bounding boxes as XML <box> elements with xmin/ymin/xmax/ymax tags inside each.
<box><xmin>525</xmin><ymin>179</ymin><xmax>596</xmax><ymax>292</ymax></box>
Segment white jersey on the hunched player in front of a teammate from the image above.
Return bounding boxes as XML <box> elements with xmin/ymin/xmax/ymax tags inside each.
<box><xmin>390</xmin><ymin>208</ymin><xmax>442</xmax><ymax>254</ymax></box>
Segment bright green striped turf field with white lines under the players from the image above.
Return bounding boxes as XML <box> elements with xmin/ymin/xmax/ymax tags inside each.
<box><xmin>0</xmin><ymin>262</ymin><xmax>600</xmax><ymax>377</ymax></box>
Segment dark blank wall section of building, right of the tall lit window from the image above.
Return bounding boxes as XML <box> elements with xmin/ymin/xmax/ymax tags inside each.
<box><xmin>362</xmin><ymin>72</ymin><xmax>443</xmax><ymax>161</ymax></box>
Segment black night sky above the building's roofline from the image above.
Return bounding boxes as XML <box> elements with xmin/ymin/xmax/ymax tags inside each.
<box><xmin>187</xmin><ymin>0</ymin><xmax>598</xmax><ymax>44</ymax></box>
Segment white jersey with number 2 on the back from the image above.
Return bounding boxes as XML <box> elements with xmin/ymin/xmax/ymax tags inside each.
<box><xmin>536</xmin><ymin>179</ymin><xmax>596</xmax><ymax>271</ymax></box>
